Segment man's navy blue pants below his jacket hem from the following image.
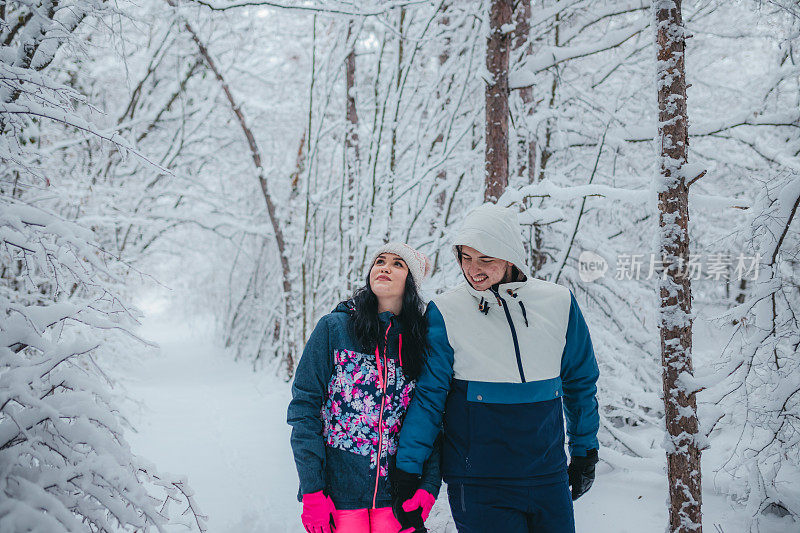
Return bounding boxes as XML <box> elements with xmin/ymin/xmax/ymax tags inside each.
<box><xmin>447</xmin><ymin>481</ymin><xmax>575</xmax><ymax>533</ymax></box>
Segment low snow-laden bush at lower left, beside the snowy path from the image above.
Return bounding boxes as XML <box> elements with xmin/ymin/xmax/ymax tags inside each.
<box><xmin>0</xmin><ymin>195</ymin><xmax>203</xmax><ymax>531</ymax></box>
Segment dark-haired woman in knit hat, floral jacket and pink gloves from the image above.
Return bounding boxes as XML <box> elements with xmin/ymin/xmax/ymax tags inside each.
<box><xmin>288</xmin><ymin>243</ymin><xmax>441</xmax><ymax>533</ymax></box>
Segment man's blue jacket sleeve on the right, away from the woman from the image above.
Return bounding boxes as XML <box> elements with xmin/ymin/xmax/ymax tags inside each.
<box><xmin>561</xmin><ymin>291</ymin><xmax>600</xmax><ymax>457</ymax></box>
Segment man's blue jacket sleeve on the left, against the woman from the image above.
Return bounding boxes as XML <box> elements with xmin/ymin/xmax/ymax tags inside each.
<box><xmin>397</xmin><ymin>302</ymin><xmax>453</xmax><ymax>475</ymax></box>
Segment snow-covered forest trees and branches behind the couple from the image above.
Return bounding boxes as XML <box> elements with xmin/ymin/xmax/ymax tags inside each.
<box><xmin>0</xmin><ymin>0</ymin><xmax>800</xmax><ymax>531</ymax></box>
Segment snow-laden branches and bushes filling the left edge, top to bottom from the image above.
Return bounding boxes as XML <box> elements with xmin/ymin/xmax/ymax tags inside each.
<box><xmin>0</xmin><ymin>0</ymin><xmax>205</xmax><ymax>532</ymax></box>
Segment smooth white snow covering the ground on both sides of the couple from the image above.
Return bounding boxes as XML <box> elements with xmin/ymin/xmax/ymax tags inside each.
<box><xmin>124</xmin><ymin>313</ymin><xmax>797</xmax><ymax>533</ymax></box>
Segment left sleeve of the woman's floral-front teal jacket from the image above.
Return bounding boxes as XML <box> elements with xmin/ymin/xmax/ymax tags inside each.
<box><xmin>286</xmin><ymin>318</ymin><xmax>333</xmax><ymax>495</ymax></box>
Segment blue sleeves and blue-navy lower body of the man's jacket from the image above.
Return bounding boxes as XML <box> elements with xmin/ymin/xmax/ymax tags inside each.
<box><xmin>397</xmin><ymin>293</ymin><xmax>599</xmax><ymax>485</ymax></box>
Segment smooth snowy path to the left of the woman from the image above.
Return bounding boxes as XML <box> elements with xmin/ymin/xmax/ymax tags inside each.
<box><xmin>127</xmin><ymin>318</ymin><xmax>303</xmax><ymax>533</ymax></box>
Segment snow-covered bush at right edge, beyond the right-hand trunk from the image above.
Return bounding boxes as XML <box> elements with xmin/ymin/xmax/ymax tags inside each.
<box><xmin>698</xmin><ymin>169</ymin><xmax>800</xmax><ymax>527</ymax></box>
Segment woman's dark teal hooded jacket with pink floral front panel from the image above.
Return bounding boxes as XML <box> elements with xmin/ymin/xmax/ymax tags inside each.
<box><xmin>287</xmin><ymin>302</ymin><xmax>441</xmax><ymax>510</ymax></box>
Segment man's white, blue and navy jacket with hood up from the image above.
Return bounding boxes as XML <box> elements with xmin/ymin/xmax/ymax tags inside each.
<box><xmin>397</xmin><ymin>205</ymin><xmax>599</xmax><ymax>485</ymax></box>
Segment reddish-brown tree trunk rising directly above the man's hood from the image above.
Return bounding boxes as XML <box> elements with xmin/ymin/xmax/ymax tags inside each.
<box><xmin>483</xmin><ymin>0</ymin><xmax>514</xmax><ymax>202</ymax></box>
